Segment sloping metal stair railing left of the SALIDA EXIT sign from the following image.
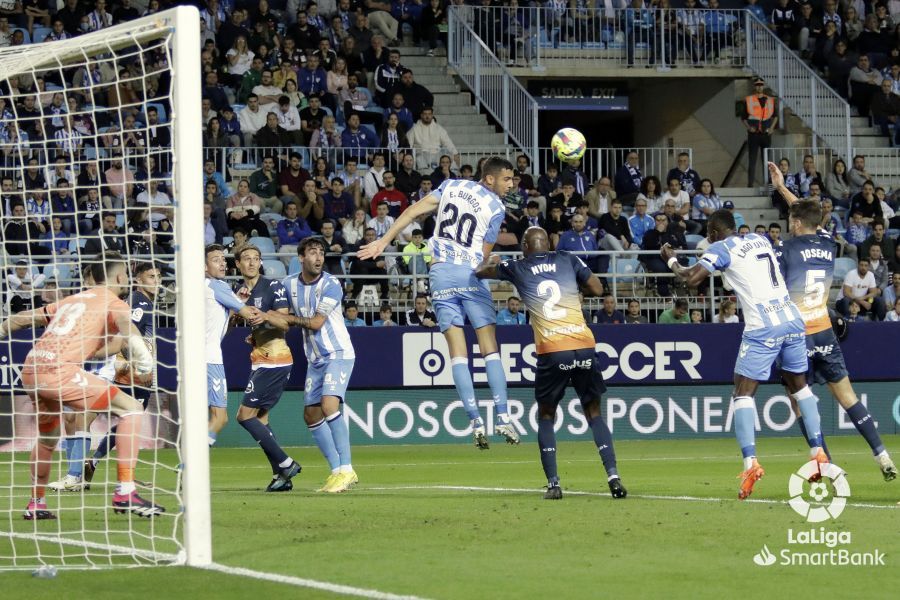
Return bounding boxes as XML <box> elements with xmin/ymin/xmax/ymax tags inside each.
<box><xmin>447</xmin><ymin>6</ymin><xmax>538</xmax><ymax>162</ymax></box>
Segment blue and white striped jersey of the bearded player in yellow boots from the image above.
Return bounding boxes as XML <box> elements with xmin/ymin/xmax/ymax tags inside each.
<box><xmin>282</xmin><ymin>273</ymin><xmax>356</xmax><ymax>364</ymax></box>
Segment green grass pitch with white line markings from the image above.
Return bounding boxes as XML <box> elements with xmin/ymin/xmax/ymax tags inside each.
<box><xmin>0</xmin><ymin>436</ymin><xmax>900</xmax><ymax>599</ymax></box>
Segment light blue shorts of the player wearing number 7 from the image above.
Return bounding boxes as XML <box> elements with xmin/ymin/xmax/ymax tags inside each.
<box><xmin>734</xmin><ymin>319</ymin><xmax>807</xmax><ymax>381</ymax></box>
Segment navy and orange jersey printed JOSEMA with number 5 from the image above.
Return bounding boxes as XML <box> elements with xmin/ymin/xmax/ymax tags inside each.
<box><xmin>775</xmin><ymin>230</ymin><xmax>837</xmax><ymax>335</ymax></box>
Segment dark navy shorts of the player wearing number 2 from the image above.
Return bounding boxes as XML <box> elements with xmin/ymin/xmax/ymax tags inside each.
<box><xmin>534</xmin><ymin>348</ymin><xmax>606</xmax><ymax>406</ymax></box>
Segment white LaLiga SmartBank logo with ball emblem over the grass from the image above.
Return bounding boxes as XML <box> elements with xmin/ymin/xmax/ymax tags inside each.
<box><xmin>753</xmin><ymin>460</ymin><xmax>885</xmax><ymax>567</ymax></box>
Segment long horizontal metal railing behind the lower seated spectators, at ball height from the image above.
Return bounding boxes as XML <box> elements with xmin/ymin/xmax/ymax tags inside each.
<box><xmin>208</xmin><ymin>146</ymin><xmax>693</xmax><ymax>188</ymax></box>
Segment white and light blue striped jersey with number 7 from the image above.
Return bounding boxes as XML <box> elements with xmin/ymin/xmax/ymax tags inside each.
<box><xmin>699</xmin><ymin>233</ymin><xmax>803</xmax><ymax>331</ymax></box>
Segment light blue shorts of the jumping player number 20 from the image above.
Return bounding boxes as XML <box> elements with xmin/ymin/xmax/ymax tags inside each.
<box><xmin>428</xmin><ymin>263</ymin><xmax>497</xmax><ymax>331</ymax></box>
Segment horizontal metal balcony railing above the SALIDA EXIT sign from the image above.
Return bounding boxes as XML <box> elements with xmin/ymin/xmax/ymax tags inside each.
<box><xmin>449</xmin><ymin>5</ymin><xmax>745</xmax><ymax>70</ymax></box>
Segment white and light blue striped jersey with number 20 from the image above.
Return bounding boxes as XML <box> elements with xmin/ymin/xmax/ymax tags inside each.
<box><xmin>429</xmin><ymin>179</ymin><xmax>506</xmax><ymax>269</ymax></box>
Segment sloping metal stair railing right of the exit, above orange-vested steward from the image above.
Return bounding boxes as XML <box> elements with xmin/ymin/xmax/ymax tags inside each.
<box><xmin>744</xmin><ymin>11</ymin><xmax>853</xmax><ymax>160</ymax></box>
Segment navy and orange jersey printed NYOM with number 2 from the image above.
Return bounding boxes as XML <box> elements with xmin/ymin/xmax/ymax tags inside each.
<box><xmin>497</xmin><ymin>252</ymin><xmax>595</xmax><ymax>354</ymax></box>
